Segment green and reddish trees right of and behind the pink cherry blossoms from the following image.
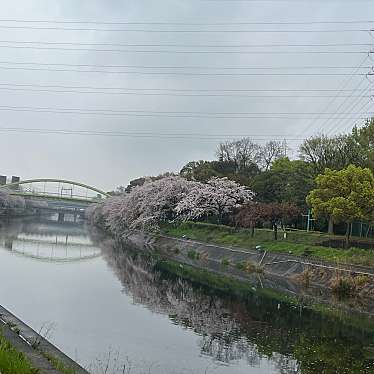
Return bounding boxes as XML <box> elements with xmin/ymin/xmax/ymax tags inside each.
<box><xmin>180</xmin><ymin>119</ymin><xmax>374</xmax><ymax>239</ymax></box>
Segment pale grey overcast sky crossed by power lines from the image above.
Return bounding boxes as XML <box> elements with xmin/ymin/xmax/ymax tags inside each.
<box><xmin>0</xmin><ymin>0</ymin><xmax>374</xmax><ymax>189</ymax></box>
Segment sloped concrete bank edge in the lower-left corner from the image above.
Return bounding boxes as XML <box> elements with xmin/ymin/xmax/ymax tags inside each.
<box><xmin>0</xmin><ymin>306</ymin><xmax>89</xmax><ymax>374</ymax></box>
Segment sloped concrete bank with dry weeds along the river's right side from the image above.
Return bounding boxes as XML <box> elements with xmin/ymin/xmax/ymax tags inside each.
<box><xmin>122</xmin><ymin>232</ymin><xmax>374</xmax><ymax>314</ymax></box>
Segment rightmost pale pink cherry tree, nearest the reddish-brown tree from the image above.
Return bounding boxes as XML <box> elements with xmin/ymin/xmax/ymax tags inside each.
<box><xmin>175</xmin><ymin>177</ymin><xmax>253</xmax><ymax>223</ymax></box>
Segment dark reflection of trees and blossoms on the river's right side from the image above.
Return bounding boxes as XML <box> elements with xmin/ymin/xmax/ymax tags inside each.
<box><xmin>95</xmin><ymin>235</ymin><xmax>374</xmax><ymax>374</ymax></box>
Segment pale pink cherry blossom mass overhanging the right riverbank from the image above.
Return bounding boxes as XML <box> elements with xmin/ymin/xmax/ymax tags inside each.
<box><xmin>88</xmin><ymin>176</ymin><xmax>253</xmax><ymax>231</ymax></box>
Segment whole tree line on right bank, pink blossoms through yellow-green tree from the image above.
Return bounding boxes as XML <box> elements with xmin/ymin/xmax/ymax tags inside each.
<box><xmin>95</xmin><ymin>119</ymin><xmax>374</xmax><ymax>244</ymax></box>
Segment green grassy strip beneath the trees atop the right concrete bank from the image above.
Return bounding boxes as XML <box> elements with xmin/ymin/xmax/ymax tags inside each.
<box><xmin>162</xmin><ymin>222</ymin><xmax>374</xmax><ymax>266</ymax></box>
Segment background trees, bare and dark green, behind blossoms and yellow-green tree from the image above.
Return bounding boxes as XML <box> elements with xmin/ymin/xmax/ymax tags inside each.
<box><xmin>180</xmin><ymin>119</ymin><xmax>374</xmax><ymax>210</ymax></box>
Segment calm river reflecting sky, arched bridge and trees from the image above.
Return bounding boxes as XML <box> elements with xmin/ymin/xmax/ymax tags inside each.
<box><xmin>0</xmin><ymin>217</ymin><xmax>374</xmax><ymax>374</ymax></box>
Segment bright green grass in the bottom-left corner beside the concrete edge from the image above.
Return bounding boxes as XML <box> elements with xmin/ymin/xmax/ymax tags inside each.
<box><xmin>0</xmin><ymin>333</ymin><xmax>40</xmax><ymax>374</ymax></box>
